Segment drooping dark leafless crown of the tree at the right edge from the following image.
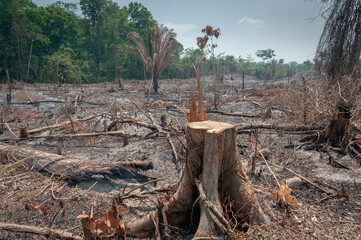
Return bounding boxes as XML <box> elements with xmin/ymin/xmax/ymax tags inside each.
<box><xmin>315</xmin><ymin>0</ymin><xmax>361</xmax><ymax>80</ymax></box>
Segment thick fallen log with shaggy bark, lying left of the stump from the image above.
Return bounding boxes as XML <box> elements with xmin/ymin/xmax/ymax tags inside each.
<box><xmin>0</xmin><ymin>143</ymin><xmax>153</xmax><ymax>182</ymax></box>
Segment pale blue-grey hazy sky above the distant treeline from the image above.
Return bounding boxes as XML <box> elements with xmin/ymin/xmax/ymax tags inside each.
<box><xmin>33</xmin><ymin>0</ymin><xmax>324</xmax><ymax>63</ymax></box>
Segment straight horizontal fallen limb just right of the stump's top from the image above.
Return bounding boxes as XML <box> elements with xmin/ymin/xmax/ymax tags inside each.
<box><xmin>237</xmin><ymin>123</ymin><xmax>324</xmax><ymax>133</ymax></box>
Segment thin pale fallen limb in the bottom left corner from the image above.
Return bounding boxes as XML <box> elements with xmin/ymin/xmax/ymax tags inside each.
<box><xmin>0</xmin><ymin>222</ymin><xmax>83</xmax><ymax>240</ymax></box>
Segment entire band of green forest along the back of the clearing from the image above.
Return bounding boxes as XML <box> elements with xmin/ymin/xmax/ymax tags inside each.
<box><xmin>0</xmin><ymin>0</ymin><xmax>313</xmax><ymax>84</ymax></box>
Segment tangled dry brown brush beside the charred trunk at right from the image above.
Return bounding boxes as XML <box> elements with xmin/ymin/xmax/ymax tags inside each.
<box><xmin>267</xmin><ymin>72</ymin><xmax>361</xmax><ymax>125</ymax></box>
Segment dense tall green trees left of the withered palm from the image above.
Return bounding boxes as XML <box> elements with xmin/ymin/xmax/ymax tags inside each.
<box><xmin>0</xmin><ymin>0</ymin><xmax>156</xmax><ymax>84</ymax></box>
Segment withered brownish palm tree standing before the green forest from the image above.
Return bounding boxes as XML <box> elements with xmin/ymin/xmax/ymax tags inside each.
<box><xmin>127</xmin><ymin>25</ymin><xmax>179</xmax><ymax>92</ymax></box>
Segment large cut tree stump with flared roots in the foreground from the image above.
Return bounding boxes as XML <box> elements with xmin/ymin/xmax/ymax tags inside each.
<box><xmin>127</xmin><ymin>121</ymin><xmax>269</xmax><ymax>237</ymax></box>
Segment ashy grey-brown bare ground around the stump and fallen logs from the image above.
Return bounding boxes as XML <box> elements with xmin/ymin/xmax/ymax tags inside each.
<box><xmin>0</xmin><ymin>75</ymin><xmax>361</xmax><ymax>239</ymax></box>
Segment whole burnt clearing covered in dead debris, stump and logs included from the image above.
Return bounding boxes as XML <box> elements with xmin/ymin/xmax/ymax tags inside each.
<box><xmin>0</xmin><ymin>75</ymin><xmax>361</xmax><ymax>239</ymax></box>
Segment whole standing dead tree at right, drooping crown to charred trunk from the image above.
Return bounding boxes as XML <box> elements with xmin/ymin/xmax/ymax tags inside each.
<box><xmin>315</xmin><ymin>0</ymin><xmax>361</xmax><ymax>150</ymax></box>
